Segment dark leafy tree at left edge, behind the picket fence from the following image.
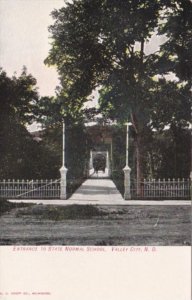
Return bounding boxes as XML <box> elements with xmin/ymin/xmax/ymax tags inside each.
<box><xmin>0</xmin><ymin>68</ymin><xmax>41</xmax><ymax>178</ymax></box>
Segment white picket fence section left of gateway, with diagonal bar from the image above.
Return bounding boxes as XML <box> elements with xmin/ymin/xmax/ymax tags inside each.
<box><xmin>0</xmin><ymin>179</ymin><xmax>60</xmax><ymax>199</ymax></box>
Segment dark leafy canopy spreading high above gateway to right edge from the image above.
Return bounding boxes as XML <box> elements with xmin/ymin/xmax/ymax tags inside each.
<box><xmin>46</xmin><ymin>0</ymin><xmax>192</xmax><ymax>125</ymax></box>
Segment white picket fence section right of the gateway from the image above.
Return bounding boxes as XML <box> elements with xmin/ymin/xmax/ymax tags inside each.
<box><xmin>131</xmin><ymin>179</ymin><xmax>191</xmax><ymax>199</ymax></box>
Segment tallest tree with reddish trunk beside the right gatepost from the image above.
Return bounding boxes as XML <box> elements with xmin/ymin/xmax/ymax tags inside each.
<box><xmin>46</xmin><ymin>0</ymin><xmax>164</xmax><ymax>195</ymax></box>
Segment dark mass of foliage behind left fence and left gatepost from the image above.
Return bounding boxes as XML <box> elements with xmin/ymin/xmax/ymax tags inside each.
<box><xmin>0</xmin><ymin>69</ymin><xmax>91</xmax><ymax>183</ymax></box>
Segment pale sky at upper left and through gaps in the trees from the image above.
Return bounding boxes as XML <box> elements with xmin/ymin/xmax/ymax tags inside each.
<box><xmin>0</xmin><ymin>0</ymin><xmax>164</xmax><ymax>128</ymax></box>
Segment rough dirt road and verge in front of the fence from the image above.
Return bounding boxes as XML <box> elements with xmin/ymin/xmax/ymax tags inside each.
<box><xmin>0</xmin><ymin>205</ymin><xmax>191</xmax><ymax>246</ymax></box>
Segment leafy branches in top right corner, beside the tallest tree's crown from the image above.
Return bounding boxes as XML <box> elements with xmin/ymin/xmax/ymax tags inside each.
<box><xmin>158</xmin><ymin>0</ymin><xmax>192</xmax><ymax>85</ymax></box>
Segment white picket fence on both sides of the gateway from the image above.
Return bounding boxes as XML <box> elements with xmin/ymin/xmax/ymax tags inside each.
<box><xmin>0</xmin><ymin>179</ymin><xmax>191</xmax><ymax>199</ymax></box>
